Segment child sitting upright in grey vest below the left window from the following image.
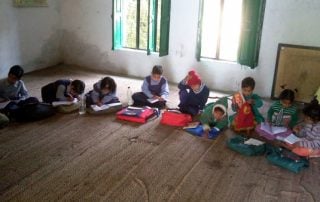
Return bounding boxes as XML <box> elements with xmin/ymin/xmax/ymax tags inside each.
<box><xmin>132</xmin><ymin>65</ymin><xmax>169</xmax><ymax>109</ymax></box>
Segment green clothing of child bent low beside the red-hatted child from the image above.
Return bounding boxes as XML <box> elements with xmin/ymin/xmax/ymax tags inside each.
<box><xmin>200</xmin><ymin>97</ymin><xmax>228</xmax><ymax>130</ymax></box>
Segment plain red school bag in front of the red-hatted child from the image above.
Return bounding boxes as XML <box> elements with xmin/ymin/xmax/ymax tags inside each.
<box><xmin>160</xmin><ymin>110</ymin><xmax>192</xmax><ymax>127</ymax></box>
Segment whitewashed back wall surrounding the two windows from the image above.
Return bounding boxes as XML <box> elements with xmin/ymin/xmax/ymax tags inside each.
<box><xmin>61</xmin><ymin>0</ymin><xmax>320</xmax><ymax>97</ymax></box>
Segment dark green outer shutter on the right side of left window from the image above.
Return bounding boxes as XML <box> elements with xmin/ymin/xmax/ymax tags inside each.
<box><xmin>159</xmin><ymin>0</ymin><xmax>171</xmax><ymax>57</ymax></box>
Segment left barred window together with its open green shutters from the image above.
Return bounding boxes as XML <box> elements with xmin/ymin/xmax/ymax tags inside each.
<box><xmin>112</xmin><ymin>0</ymin><xmax>170</xmax><ymax>56</ymax></box>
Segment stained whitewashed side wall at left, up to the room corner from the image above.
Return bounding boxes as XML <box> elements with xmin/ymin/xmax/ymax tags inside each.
<box><xmin>0</xmin><ymin>0</ymin><xmax>61</xmax><ymax>78</ymax></box>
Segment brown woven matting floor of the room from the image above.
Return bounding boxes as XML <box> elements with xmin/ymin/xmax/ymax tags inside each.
<box><xmin>0</xmin><ymin>66</ymin><xmax>320</xmax><ymax>201</ymax></box>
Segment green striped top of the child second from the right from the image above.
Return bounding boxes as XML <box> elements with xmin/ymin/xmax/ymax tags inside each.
<box><xmin>268</xmin><ymin>100</ymin><xmax>298</xmax><ymax>128</ymax></box>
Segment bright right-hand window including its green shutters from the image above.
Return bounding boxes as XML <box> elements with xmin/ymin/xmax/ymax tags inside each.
<box><xmin>197</xmin><ymin>0</ymin><xmax>265</xmax><ymax>68</ymax></box>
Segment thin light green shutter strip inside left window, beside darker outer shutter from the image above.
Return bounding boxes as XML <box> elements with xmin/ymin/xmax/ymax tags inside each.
<box><xmin>147</xmin><ymin>0</ymin><xmax>158</xmax><ymax>55</ymax></box>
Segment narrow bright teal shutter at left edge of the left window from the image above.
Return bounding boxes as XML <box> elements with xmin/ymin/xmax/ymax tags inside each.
<box><xmin>112</xmin><ymin>0</ymin><xmax>123</xmax><ymax>50</ymax></box>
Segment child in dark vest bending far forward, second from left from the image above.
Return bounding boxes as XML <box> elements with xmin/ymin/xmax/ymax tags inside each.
<box><xmin>41</xmin><ymin>80</ymin><xmax>85</xmax><ymax>103</ymax></box>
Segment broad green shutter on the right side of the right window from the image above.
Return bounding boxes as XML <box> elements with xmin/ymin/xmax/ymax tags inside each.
<box><xmin>238</xmin><ymin>0</ymin><xmax>266</xmax><ymax>69</ymax></box>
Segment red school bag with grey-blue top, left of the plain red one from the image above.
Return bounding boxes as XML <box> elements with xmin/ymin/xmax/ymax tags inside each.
<box><xmin>116</xmin><ymin>106</ymin><xmax>159</xmax><ymax>123</ymax></box>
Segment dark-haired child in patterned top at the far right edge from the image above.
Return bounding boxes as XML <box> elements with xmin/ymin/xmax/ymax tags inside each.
<box><xmin>292</xmin><ymin>99</ymin><xmax>320</xmax><ymax>157</ymax></box>
